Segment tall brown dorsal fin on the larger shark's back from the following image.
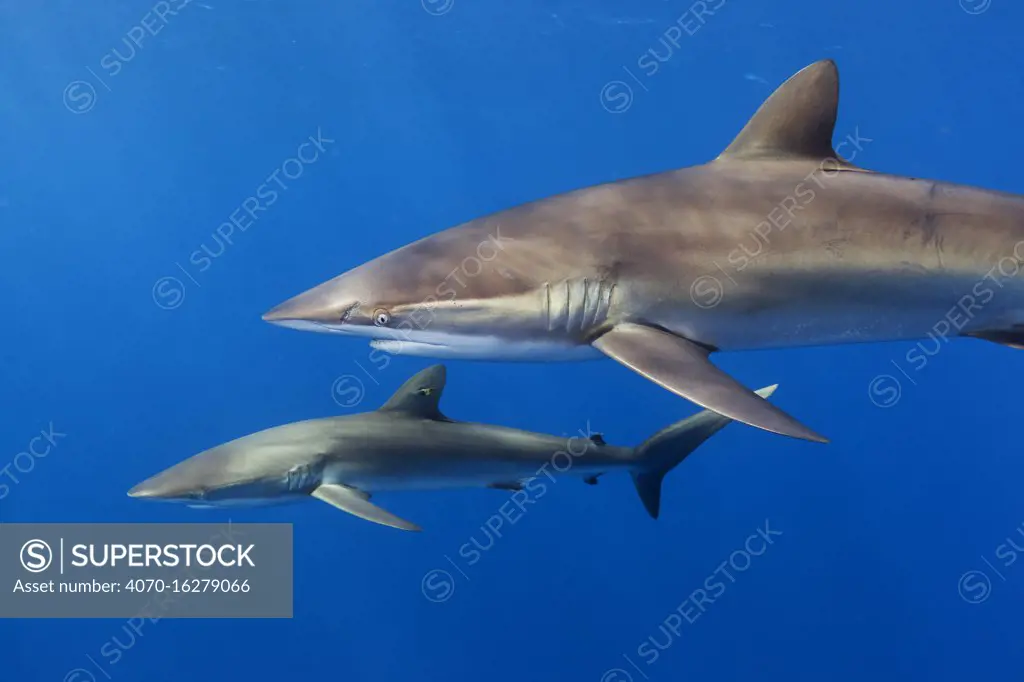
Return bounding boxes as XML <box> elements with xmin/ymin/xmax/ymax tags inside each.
<box><xmin>718</xmin><ymin>59</ymin><xmax>861</xmax><ymax>170</ymax></box>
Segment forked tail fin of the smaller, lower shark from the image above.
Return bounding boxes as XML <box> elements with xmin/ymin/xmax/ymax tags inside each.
<box><xmin>632</xmin><ymin>384</ymin><xmax>778</xmax><ymax>518</ymax></box>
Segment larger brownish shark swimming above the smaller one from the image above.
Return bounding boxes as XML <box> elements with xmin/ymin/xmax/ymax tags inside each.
<box><xmin>263</xmin><ymin>60</ymin><xmax>1024</xmax><ymax>441</ymax></box>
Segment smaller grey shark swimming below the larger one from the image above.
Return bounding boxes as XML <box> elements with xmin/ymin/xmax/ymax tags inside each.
<box><xmin>128</xmin><ymin>365</ymin><xmax>777</xmax><ymax>530</ymax></box>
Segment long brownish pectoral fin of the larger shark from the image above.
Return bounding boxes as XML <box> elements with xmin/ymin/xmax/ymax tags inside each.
<box><xmin>593</xmin><ymin>323</ymin><xmax>828</xmax><ymax>442</ymax></box>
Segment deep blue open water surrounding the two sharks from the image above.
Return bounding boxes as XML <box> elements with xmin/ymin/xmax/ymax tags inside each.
<box><xmin>0</xmin><ymin>0</ymin><xmax>1024</xmax><ymax>682</ymax></box>
